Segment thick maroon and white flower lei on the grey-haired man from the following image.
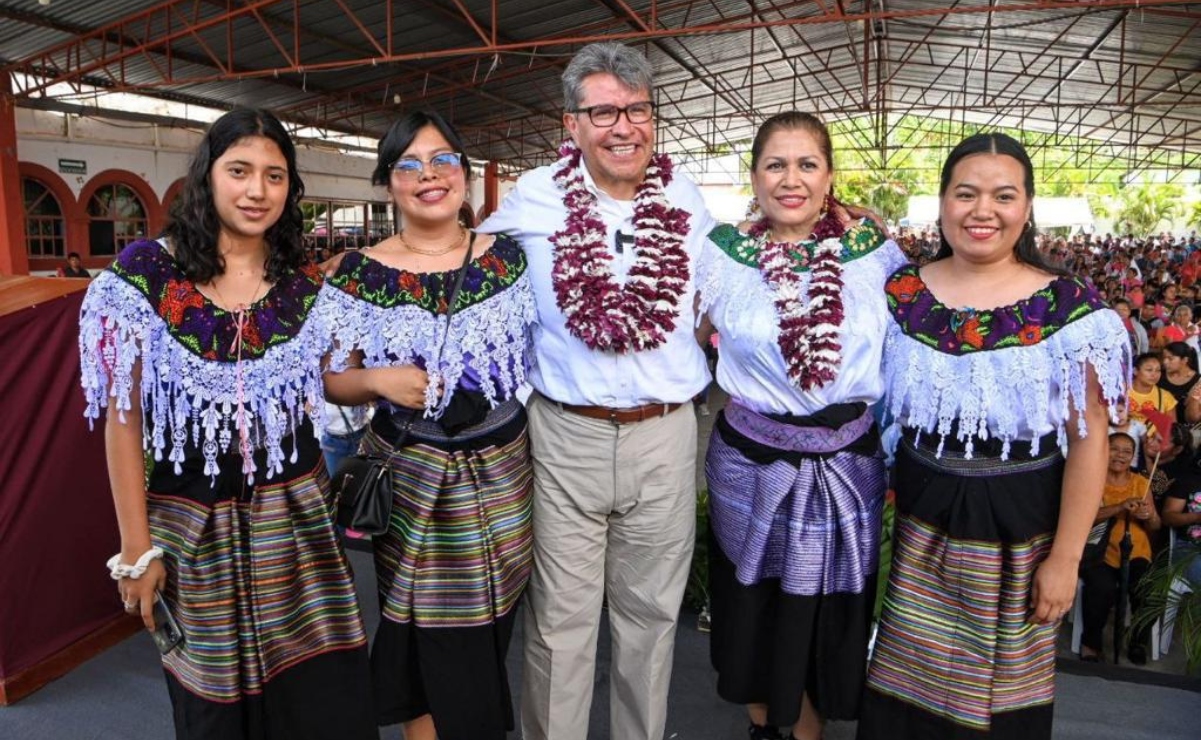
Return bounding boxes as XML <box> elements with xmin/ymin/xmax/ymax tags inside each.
<box><xmin>550</xmin><ymin>139</ymin><xmax>688</xmax><ymax>353</ymax></box>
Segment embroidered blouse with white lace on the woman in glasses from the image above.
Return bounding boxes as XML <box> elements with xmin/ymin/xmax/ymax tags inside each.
<box><xmin>318</xmin><ymin>235</ymin><xmax>536</xmax><ymax>416</ymax></box>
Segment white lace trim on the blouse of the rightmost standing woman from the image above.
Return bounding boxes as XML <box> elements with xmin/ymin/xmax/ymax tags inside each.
<box><xmin>884</xmin><ymin>310</ymin><xmax>1130</xmax><ymax>460</ymax></box>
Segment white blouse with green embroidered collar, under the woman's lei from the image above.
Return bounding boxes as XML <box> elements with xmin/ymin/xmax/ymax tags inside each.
<box><xmin>697</xmin><ymin>221</ymin><xmax>907</xmax><ymax>416</ymax></box>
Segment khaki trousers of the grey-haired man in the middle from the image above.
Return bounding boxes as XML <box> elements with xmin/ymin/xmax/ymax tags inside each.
<box><xmin>521</xmin><ymin>394</ymin><xmax>697</xmax><ymax>740</ymax></box>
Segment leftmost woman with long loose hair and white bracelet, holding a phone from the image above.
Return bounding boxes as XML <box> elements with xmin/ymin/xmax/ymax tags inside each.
<box><xmin>79</xmin><ymin>109</ymin><xmax>378</xmax><ymax>740</ymax></box>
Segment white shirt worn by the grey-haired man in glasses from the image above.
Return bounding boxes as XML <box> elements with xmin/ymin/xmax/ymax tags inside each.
<box><xmin>479</xmin><ymin>158</ymin><xmax>716</xmax><ymax>408</ymax></box>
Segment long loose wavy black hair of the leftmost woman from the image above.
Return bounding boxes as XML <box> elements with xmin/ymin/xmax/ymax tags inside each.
<box><xmin>163</xmin><ymin>108</ymin><xmax>306</xmax><ymax>282</ymax></box>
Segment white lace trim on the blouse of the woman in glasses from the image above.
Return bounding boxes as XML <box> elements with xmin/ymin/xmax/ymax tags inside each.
<box><xmin>316</xmin><ymin>273</ymin><xmax>537</xmax><ymax>418</ymax></box>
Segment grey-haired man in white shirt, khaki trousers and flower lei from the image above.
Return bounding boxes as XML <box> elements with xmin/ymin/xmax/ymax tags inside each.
<box><xmin>480</xmin><ymin>43</ymin><xmax>713</xmax><ymax>740</ymax></box>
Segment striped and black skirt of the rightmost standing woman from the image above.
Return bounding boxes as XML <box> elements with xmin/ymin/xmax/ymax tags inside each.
<box><xmin>859</xmin><ymin>430</ymin><xmax>1063</xmax><ymax>740</ymax></box>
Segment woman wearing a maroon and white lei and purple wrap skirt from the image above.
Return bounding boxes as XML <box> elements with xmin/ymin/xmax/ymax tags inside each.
<box><xmin>697</xmin><ymin>112</ymin><xmax>906</xmax><ymax>740</ymax></box>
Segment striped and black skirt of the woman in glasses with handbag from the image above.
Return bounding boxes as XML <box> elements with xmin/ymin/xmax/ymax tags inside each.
<box><xmin>364</xmin><ymin>400</ymin><xmax>533</xmax><ymax>740</ymax></box>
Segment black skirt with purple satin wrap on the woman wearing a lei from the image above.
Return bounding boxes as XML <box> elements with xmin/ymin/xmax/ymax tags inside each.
<box><xmin>706</xmin><ymin>405</ymin><xmax>885</xmax><ymax>726</ymax></box>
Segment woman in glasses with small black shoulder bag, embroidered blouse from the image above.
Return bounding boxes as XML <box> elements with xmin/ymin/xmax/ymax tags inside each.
<box><xmin>318</xmin><ymin>112</ymin><xmax>534</xmax><ymax>740</ymax></box>
